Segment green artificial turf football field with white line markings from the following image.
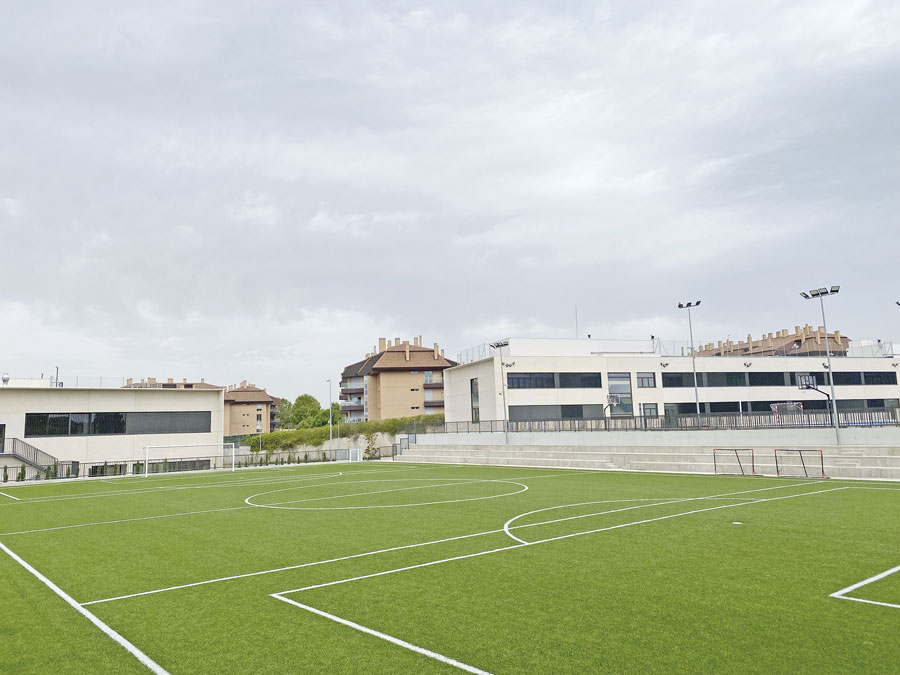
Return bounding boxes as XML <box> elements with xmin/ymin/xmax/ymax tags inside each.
<box><xmin>0</xmin><ymin>462</ymin><xmax>900</xmax><ymax>673</ymax></box>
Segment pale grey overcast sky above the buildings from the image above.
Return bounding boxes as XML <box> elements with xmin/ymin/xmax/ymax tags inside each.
<box><xmin>0</xmin><ymin>0</ymin><xmax>900</xmax><ymax>399</ymax></box>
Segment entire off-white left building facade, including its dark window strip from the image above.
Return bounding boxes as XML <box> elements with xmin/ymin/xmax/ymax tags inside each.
<box><xmin>0</xmin><ymin>387</ymin><xmax>224</xmax><ymax>462</ymax></box>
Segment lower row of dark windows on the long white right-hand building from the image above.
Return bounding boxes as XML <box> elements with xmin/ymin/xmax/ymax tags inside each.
<box><xmin>510</xmin><ymin>398</ymin><xmax>900</xmax><ymax>422</ymax></box>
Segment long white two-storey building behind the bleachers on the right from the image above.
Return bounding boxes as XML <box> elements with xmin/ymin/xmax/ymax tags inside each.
<box><xmin>444</xmin><ymin>336</ymin><xmax>900</xmax><ymax>422</ymax></box>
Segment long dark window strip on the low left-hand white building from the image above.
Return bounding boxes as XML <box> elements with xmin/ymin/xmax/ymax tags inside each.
<box><xmin>25</xmin><ymin>410</ymin><xmax>212</xmax><ymax>438</ymax></box>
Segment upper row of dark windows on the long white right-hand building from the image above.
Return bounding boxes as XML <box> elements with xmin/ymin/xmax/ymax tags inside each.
<box><xmin>506</xmin><ymin>371</ymin><xmax>897</xmax><ymax>393</ymax></box>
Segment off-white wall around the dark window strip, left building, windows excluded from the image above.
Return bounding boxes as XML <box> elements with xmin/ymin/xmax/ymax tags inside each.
<box><xmin>0</xmin><ymin>387</ymin><xmax>224</xmax><ymax>462</ymax></box>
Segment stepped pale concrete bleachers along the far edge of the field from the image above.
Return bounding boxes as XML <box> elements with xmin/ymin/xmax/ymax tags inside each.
<box><xmin>396</xmin><ymin>430</ymin><xmax>900</xmax><ymax>480</ymax></box>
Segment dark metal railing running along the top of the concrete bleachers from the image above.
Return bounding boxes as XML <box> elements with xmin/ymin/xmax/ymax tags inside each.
<box><xmin>422</xmin><ymin>409</ymin><xmax>900</xmax><ymax>443</ymax></box>
